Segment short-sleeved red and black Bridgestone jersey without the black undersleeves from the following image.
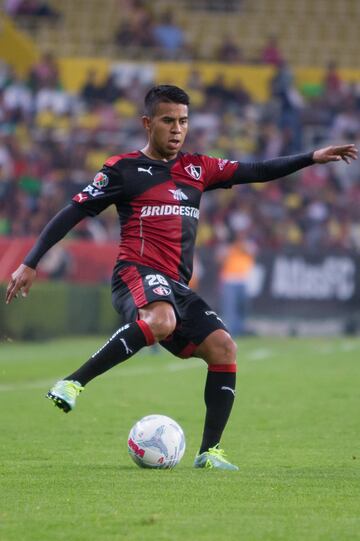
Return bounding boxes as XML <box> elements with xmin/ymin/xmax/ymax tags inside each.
<box><xmin>73</xmin><ymin>151</ymin><xmax>239</xmax><ymax>283</ymax></box>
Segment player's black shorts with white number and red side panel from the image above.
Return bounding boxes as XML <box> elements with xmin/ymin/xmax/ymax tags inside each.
<box><xmin>112</xmin><ymin>262</ymin><xmax>228</xmax><ymax>358</ymax></box>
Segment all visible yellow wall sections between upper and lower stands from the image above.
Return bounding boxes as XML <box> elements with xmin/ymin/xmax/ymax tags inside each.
<box><xmin>0</xmin><ymin>17</ymin><xmax>360</xmax><ymax>95</ymax></box>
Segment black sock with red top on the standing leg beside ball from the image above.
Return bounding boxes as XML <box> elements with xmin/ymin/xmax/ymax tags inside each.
<box><xmin>200</xmin><ymin>363</ymin><xmax>236</xmax><ymax>454</ymax></box>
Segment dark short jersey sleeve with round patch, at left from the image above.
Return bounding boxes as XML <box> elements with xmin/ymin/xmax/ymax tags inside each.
<box><xmin>72</xmin><ymin>164</ymin><xmax>123</xmax><ymax>216</ymax></box>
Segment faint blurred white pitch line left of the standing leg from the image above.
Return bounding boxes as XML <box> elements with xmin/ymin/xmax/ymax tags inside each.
<box><xmin>0</xmin><ymin>359</ymin><xmax>205</xmax><ymax>392</ymax></box>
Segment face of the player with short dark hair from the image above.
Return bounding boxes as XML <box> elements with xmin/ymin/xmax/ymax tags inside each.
<box><xmin>143</xmin><ymin>102</ymin><xmax>188</xmax><ymax>160</ymax></box>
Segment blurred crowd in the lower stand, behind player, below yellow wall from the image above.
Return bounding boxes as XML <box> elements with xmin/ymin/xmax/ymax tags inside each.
<box><xmin>0</xmin><ymin>51</ymin><xmax>360</xmax><ymax>258</ymax></box>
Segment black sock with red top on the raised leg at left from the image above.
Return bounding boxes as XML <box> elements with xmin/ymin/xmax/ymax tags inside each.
<box><xmin>65</xmin><ymin>320</ymin><xmax>155</xmax><ymax>385</ymax></box>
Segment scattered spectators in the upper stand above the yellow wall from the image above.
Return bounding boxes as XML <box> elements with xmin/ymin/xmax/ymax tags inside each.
<box><xmin>4</xmin><ymin>0</ymin><xmax>296</xmax><ymax>65</ymax></box>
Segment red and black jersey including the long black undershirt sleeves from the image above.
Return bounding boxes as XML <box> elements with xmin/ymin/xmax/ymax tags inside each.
<box><xmin>24</xmin><ymin>151</ymin><xmax>314</xmax><ymax>274</ymax></box>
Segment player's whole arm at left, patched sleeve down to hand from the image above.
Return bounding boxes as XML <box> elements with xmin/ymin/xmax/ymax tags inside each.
<box><xmin>5</xmin><ymin>160</ymin><xmax>122</xmax><ymax>304</ymax></box>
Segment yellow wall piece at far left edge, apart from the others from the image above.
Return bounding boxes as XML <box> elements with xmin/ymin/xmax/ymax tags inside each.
<box><xmin>0</xmin><ymin>14</ymin><xmax>39</xmax><ymax>76</ymax></box>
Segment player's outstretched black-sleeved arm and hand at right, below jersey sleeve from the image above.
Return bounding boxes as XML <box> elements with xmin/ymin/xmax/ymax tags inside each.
<box><xmin>232</xmin><ymin>145</ymin><xmax>357</xmax><ymax>184</ymax></box>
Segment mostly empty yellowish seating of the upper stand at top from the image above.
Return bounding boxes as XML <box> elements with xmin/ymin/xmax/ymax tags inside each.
<box><xmin>7</xmin><ymin>0</ymin><xmax>360</xmax><ymax>67</ymax></box>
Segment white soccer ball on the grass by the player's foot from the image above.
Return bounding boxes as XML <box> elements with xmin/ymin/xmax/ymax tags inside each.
<box><xmin>128</xmin><ymin>415</ymin><xmax>185</xmax><ymax>469</ymax></box>
